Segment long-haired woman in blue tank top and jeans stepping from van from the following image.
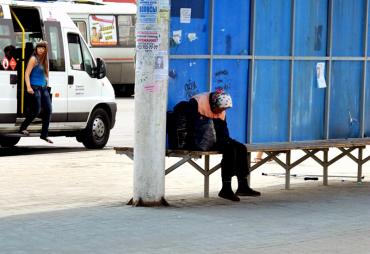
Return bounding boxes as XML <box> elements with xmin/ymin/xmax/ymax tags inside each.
<box><xmin>19</xmin><ymin>41</ymin><xmax>53</xmax><ymax>143</ymax></box>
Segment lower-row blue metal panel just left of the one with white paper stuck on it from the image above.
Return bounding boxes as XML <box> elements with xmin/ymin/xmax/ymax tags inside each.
<box><xmin>252</xmin><ymin>60</ymin><xmax>289</xmax><ymax>143</ymax></box>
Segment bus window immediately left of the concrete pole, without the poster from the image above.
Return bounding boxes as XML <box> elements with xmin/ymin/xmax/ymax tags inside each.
<box><xmin>118</xmin><ymin>15</ymin><xmax>135</xmax><ymax>47</ymax></box>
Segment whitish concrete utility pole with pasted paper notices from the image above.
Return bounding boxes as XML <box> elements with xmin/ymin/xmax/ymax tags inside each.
<box><xmin>131</xmin><ymin>0</ymin><xmax>170</xmax><ymax>206</ymax></box>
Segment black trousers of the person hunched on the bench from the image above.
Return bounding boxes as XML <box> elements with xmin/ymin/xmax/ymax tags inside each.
<box><xmin>221</xmin><ymin>140</ymin><xmax>249</xmax><ymax>182</ymax></box>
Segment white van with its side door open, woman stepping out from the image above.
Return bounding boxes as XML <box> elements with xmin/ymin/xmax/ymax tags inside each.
<box><xmin>0</xmin><ymin>1</ymin><xmax>117</xmax><ymax>148</ymax></box>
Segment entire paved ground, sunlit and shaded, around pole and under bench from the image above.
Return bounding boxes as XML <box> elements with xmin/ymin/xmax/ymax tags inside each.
<box><xmin>0</xmin><ymin>149</ymin><xmax>370</xmax><ymax>254</ymax></box>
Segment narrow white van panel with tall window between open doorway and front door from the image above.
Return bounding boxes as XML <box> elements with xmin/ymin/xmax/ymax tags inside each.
<box><xmin>44</xmin><ymin>21</ymin><xmax>68</xmax><ymax>123</ymax></box>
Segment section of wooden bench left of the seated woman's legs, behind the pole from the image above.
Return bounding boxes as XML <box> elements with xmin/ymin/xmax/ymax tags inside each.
<box><xmin>114</xmin><ymin>147</ymin><xmax>221</xmax><ymax>198</ymax></box>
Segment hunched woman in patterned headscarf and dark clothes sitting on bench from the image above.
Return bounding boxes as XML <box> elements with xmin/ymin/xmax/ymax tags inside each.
<box><xmin>188</xmin><ymin>89</ymin><xmax>261</xmax><ymax>201</ymax></box>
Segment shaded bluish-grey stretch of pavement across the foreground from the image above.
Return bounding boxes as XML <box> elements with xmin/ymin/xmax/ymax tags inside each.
<box><xmin>0</xmin><ymin>182</ymin><xmax>370</xmax><ymax>253</ymax></box>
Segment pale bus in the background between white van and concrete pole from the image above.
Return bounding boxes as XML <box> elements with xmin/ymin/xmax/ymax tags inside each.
<box><xmin>54</xmin><ymin>2</ymin><xmax>136</xmax><ymax>95</ymax></box>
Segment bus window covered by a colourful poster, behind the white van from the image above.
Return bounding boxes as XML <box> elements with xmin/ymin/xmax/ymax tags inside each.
<box><xmin>89</xmin><ymin>15</ymin><xmax>117</xmax><ymax>46</ymax></box>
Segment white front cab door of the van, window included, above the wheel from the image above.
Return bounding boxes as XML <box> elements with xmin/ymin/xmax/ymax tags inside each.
<box><xmin>67</xmin><ymin>32</ymin><xmax>99</xmax><ymax>122</ymax></box>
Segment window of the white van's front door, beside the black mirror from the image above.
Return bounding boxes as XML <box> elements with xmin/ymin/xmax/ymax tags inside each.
<box><xmin>68</xmin><ymin>33</ymin><xmax>95</xmax><ymax>76</ymax></box>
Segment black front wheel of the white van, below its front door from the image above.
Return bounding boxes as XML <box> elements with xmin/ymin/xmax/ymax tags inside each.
<box><xmin>82</xmin><ymin>108</ymin><xmax>110</xmax><ymax>149</ymax></box>
